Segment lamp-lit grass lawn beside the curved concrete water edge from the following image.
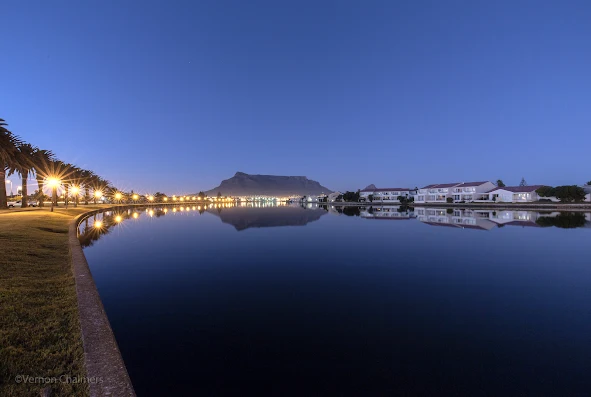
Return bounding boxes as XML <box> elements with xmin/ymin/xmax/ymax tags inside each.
<box><xmin>0</xmin><ymin>205</ymin><xmax>105</xmax><ymax>396</ymax></box>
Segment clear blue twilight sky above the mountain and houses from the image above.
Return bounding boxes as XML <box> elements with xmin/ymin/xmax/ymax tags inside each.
<box><xmin>0</xmin><ymin>0</ymin><xmax>591</xmax><ymax>194</ymax></box>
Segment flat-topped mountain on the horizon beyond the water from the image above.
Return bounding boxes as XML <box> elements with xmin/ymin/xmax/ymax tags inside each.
<box><xmin>205</xmin><ymin>172</ymin><xmax>332</xmax><ymax>197</ymax></box>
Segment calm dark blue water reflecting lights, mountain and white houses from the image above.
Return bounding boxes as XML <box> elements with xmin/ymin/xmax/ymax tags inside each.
<box><xmin>81</xmin><ymin>207</ymin><xmax>591</xmax><ymax>396</ymax></box>
